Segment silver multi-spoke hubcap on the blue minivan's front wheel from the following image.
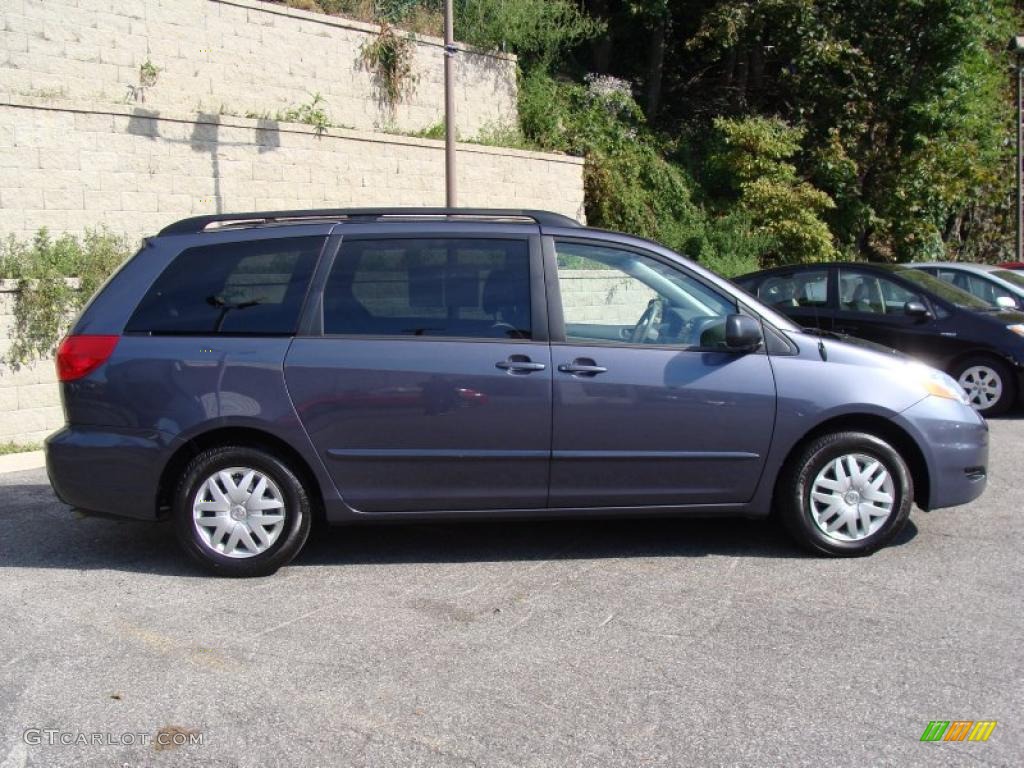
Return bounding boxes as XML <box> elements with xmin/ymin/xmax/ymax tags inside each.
<box><xmin>811</xmin><ymin>454</ymin><xmax>896</xmax><ymax>542</ymax></box>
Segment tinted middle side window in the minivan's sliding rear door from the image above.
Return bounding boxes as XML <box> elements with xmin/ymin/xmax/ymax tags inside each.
<box><xmin>324</xmin><ymin>238</ymin><xmax>532</xmax><ymax>339</ymax></box>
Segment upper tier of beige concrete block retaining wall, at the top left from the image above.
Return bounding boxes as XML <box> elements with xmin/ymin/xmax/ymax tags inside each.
<box><xmin>0</xmin><ymin>0</ymin><xmax>516</xmax><ymax>138</ymax></box>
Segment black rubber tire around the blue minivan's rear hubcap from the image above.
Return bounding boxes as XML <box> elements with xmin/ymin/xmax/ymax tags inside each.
<box><xmin>173</xmin><ymin>445</ymin><xmax>312</xmax><ymax>577</ymax></box>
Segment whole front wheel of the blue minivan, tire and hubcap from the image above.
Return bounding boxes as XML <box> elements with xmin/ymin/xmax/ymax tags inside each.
<box><xmin>775</xmin><ymin>432</ymin><xmax>913</xmax><ymax>557</ymax></box>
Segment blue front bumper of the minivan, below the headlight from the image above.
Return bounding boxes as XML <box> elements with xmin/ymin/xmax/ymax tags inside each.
<box><xmin>896</xmin><ymin>397</ymin><xmax>988</xmax><ymax>509</ymax></box>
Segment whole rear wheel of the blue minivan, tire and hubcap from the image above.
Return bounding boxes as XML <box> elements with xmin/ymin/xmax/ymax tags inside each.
<box><xmin>174</xmin><ymin>445</ymin><xmax>311</xmax><ymax>577</ymax></box>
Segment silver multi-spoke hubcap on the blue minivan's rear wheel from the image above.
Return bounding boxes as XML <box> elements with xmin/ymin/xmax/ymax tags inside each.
<box><xmin>193</xmin><ymin>467</ymin><xmax>285</xmax><ymax>557</ymax></box>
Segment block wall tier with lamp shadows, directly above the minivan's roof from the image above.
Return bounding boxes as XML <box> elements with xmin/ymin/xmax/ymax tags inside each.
<box><xmin>0</xmin><ymin>97</ymin><xmax>584</xmax><ymax>243</ymax></box>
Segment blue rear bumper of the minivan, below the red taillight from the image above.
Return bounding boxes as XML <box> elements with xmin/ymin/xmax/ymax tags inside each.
<box><xmin>46</xmin><ymin>426</ymin><xmax>171</xmax><ymax>520</ymax></box>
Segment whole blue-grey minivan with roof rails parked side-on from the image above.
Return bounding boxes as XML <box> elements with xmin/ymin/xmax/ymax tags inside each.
<box><xmin>46</xmin><ymin>209</ymin><xmax>988</xmax><ymax>575</ymax></box>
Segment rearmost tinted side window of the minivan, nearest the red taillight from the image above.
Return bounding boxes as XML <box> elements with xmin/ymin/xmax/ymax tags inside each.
<box><xmin>125</xmin><ymin>237</ymin><xmax>325</xmax><ymax>336</ymax></box>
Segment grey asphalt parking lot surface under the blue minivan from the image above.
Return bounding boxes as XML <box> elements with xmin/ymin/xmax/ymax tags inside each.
<box><xmin>0</xmin><ymin>418</ymin><xmax>1024</xmax><ymax>768</ymax></box>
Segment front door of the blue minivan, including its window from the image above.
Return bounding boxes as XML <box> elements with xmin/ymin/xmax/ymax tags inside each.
<box><xmin>547</xmin><ymin>240</ymin><xmax>775</xmax><ymax>508</ymax></box>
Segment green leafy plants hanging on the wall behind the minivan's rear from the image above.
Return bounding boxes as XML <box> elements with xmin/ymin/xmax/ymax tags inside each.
<box><xmin>0</xmin><ymin>229</ymin><xmax>131</xmax><ymax>369</ymax></box>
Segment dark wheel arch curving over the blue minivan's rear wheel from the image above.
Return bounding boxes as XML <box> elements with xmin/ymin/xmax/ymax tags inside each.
<box><xmin>157</xmin><ymin>426</ymin><xmax>325</xmax><ymax>518</ymax></box>
